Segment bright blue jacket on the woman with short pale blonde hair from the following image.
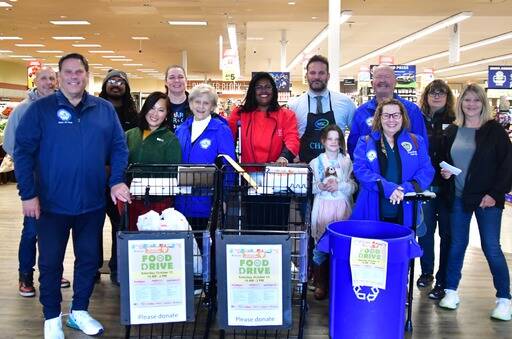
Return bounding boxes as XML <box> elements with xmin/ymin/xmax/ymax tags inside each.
<box><xmin>175</xmin><ymin>117</ymin><xmax>236</xmax><ymax>218</ymax></box>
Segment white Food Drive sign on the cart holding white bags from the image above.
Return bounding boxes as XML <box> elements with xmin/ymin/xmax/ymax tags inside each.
<box><xmin>128</xmin><ymin>239</ymin><xmax>187</xmax><ymax>324</ymax></box>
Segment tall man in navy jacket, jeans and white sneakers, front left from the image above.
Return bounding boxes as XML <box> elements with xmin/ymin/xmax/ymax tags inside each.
<box><xmin>14</xmin><ymin>53</ymin><xmax>130</xmax><ymax>339</ymax></box>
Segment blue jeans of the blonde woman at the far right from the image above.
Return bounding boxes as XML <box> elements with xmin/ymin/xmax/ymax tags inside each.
<box><xmin>445</xmin><ymin>197</ymin><xmax>510</xmax><ymax>299</ymax></box>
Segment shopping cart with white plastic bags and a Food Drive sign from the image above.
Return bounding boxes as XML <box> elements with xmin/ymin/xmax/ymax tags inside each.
<box><xmin>118</xmin><ymin>165</ymin><xmax>220</xmax><ymax>339</ymax></box>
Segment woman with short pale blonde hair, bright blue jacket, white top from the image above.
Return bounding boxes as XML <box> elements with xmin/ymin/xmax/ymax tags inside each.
<box><xmin>176</xmin><ymin>84</ymin><xmax>236</xmax><ymax>235</ymax></box>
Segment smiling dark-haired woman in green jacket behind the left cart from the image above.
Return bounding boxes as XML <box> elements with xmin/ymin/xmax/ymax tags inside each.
<box><xmin>126</xmin><ymin>92</ymin><xmax>181</xmax><ymax>231</ymax></box>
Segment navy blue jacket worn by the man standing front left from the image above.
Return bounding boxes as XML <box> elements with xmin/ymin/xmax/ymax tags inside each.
<box><xmin>14</xmin><ymin>91</ymin><xmax>128</xmax><ymax>215</ymax></box>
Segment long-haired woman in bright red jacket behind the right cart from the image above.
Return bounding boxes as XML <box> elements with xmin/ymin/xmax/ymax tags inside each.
<box><xmin>228</xmin><ymin>72</ymin><xmax>300</xmax><ymax>230</ymax></box>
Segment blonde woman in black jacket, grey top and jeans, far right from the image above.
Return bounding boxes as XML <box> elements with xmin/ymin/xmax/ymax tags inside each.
<box><xmin>439</xmin><ymin>84</ymin><xmax>512</xmax><ymax>320</ymax></box>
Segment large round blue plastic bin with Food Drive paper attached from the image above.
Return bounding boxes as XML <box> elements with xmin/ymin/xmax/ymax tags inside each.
<box><xmin>318</xmin><ymin>220</ymin><xmax>422</xmax><ymax>339</ymax></box>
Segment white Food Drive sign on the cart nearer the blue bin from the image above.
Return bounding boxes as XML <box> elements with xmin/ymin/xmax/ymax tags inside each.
<box><xmin>226</xmin><ymin>244</ymin><xmax>283</xmax><ymax>326</ymax></box>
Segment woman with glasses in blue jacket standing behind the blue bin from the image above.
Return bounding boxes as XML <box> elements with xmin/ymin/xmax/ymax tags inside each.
<box><xmin>351</xmin><ymin>99</ymin><xmax>434</xmax><ymax>227</ymax></box>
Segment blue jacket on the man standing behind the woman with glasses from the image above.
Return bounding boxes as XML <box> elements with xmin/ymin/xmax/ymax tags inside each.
<box><xmin>347</xmin><ymin>94</ymin><xmax>428</xmax><ymax>159</ymax></box>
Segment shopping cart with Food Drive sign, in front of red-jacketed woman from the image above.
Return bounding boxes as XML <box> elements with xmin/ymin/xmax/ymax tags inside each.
<box><xmin>215</xmin><ymin>164</ymin><xmax>312</xmax><ymax>339</ymax></box>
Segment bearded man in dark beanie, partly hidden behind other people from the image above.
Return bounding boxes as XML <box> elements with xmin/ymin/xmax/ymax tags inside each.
<box><xmin>96</xmin><ymin>69</ymin><xmax>138</xmax><ymax>285</ymax></box>
